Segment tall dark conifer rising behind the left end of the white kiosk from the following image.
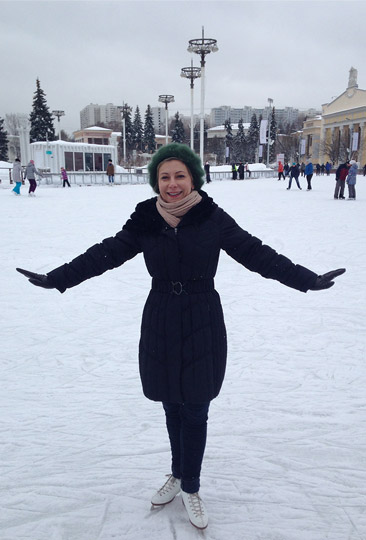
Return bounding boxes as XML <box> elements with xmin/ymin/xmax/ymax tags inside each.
<box><xmin>29</xmin><ymin>78</ymin><xmax>55</xmax><ymax>142</ymax></box>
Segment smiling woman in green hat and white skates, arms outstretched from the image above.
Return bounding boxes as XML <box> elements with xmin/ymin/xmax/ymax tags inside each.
<box><xmin>17</xmin><ymin>143</ymin><xmax>345</xmax><ymax>529</ymax></box>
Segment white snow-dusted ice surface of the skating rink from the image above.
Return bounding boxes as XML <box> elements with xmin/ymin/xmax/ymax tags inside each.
<box><xmin>0</xmin><ymin>176</ymin><xmax>366</xmax><ymax>540</ymax></box>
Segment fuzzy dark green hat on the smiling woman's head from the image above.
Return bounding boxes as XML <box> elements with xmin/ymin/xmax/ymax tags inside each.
<box><xmin>147</xmin><ymin>143</ymin><xmax>205</xmax><ymax>193</ymax></box>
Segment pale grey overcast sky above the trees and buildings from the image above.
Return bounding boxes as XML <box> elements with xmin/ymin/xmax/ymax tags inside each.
<box><xmin>0</xmin><ymin>0</ymin><xmax>366</xmax><ymax>133</ymax></box>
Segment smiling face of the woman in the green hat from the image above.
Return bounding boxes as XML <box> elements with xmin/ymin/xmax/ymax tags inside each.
<box><xmin>158</xmin><ymin>159</ymin><xmax>194</xmax><ymax>202</ymax></box>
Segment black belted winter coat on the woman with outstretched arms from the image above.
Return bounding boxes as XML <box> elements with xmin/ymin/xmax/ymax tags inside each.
<box><xmin>48</xmin><ymin>191</ymin><xmax>317</xmax><ymax>403</ymax></box>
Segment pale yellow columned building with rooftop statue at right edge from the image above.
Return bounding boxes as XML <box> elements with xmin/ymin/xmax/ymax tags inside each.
<box><xmin>303</xmin><ymin>67</ymin><xmax>366</xmax><ymax>166</ymax></box>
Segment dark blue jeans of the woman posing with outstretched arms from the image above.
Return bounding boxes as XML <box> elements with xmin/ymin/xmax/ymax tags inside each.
<box><xmin>163</xmin><ymin>401</ymin><xmax>210</xmax><ymax>493</ymax></box>
